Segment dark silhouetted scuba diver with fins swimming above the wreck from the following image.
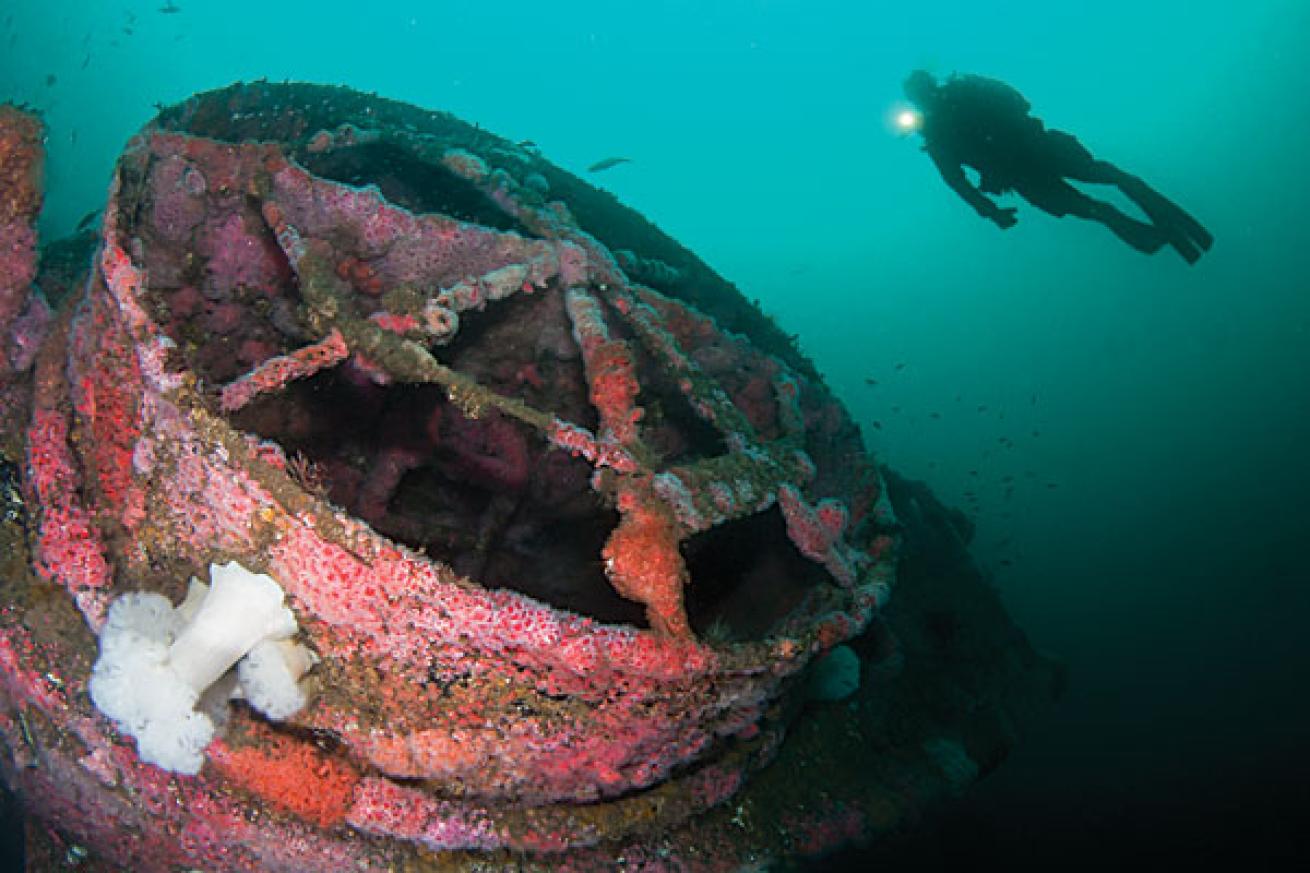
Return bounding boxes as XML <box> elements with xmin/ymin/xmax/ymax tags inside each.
<box><xmin>905</xmin><ymin>69</ymin><xmax>1214</xmax><ymax>263</ymax></box>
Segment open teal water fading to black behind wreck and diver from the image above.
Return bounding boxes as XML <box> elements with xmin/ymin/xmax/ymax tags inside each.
<box><xmin>0</xmin><ymin>0</ymin><xmax>1310</xmax><ymax>852</ymax></box>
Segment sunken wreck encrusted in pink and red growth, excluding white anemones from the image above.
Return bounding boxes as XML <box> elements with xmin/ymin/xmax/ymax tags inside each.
<box><xmin>0</xmin><ymin>83</ymin><xmax>1063</xmax><ymax>870</ymax></box>
